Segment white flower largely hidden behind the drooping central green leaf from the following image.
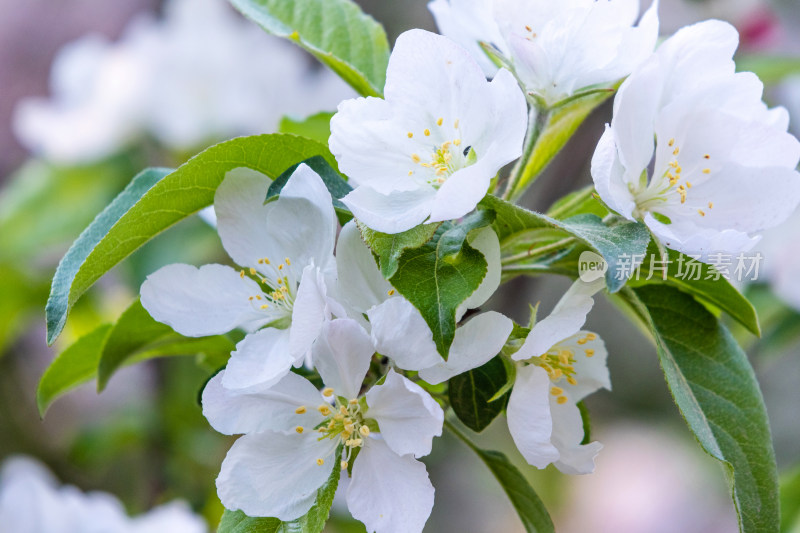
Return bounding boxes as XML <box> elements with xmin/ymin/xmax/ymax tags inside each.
<box><xmin>336</xmin><ymin>223</ymin><xmax>514</xmax><ymax>383</ymax></box>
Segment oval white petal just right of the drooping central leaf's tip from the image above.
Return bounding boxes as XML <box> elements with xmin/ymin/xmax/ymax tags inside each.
<box><xmin>419</xmin><ymin>311</ymin><xmax>514</xmax><ymax>384</ymax></box>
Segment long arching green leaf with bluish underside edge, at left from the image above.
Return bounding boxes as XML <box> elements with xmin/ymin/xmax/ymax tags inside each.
<box><xmin>46</xmin><ymin>134</ymin><xmax>336</xmax><ymax>344</ymax></box>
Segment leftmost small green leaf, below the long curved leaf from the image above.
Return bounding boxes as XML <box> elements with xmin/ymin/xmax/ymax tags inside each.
<box><xmin>36</xmin><ymin>324</ymin><xmax>112</xmax><ymax>418</ymax></box>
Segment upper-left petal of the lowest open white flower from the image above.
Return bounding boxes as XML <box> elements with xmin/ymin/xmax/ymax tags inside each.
<box><xmin>203</xmin><ymin>371</ymin><xmax>323</xmax><ymax>435</ymax></box>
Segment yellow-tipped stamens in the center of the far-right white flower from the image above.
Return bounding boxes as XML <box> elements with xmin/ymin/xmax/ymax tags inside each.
<box><xmin>628</xmin><ymin>138</ymin><xmax>714</xmax><ymax>222</ymax></box>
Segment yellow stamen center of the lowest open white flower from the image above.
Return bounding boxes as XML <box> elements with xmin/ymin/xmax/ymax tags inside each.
<box><xmin>295</xmin><ymin>388</ymin><xmax>377</xmax><ymax>470</ymax></box>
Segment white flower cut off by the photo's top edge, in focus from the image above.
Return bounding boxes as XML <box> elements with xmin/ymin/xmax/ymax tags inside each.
<box><xmin>430</xmin><ymin>0</ymin><xmax>658</xmax><ymax>105</ymax></box>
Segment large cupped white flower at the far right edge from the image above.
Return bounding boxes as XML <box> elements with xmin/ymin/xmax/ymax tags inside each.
<box><xmin>592</xmin><ymin>21</ymin><xmax>800</xmax><ymax>261</ymax></box>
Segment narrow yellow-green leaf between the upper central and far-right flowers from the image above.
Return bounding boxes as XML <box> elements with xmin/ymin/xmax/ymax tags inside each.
<box><xmin>510</xmin><ymin>89</ymin><xmax>614</xmax><ymax>198</ymax></box>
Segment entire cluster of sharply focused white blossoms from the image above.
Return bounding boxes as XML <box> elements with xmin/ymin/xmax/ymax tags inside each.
<box><xmin>141</xmin><ymin>0</ymin><xmax>800</xmax><ymax>533</ymax></box>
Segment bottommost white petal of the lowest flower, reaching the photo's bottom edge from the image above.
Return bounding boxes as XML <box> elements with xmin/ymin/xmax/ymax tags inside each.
<box><xmin>347</xmin><ymin>438</ymin><xmax>434</xmax><ymax>533</ymax></box>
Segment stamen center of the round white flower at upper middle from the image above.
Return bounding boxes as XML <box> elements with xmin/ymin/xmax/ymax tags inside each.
<box><xmin>407</xmin><ymin>117</ymin><xmax>476</xmax><ymax>188</ymax></box>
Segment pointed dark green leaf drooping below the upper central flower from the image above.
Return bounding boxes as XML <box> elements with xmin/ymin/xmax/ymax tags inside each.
<box><xmin>389</xmin><ymin>211</ymin><xmax>494</xmax><ymax>359</ymax></box>
